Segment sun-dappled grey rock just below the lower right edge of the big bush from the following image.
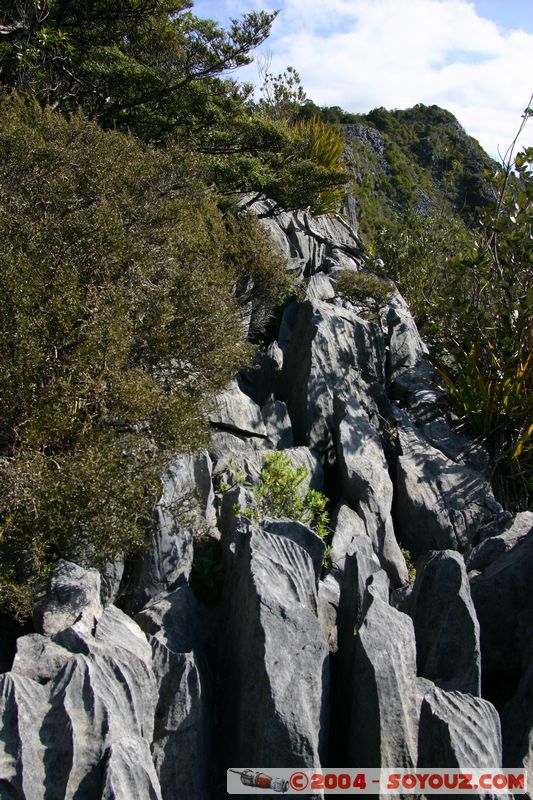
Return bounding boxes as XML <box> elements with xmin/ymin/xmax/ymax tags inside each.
<box><xmin>122</xmin><ymin>452</ymin><xmax>216</xmax><ymax>613</ymax></box>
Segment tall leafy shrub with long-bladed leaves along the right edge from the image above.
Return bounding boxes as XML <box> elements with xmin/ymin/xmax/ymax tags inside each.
<box><xmin>442</xmin><ymin>141</ymin><xmax>533</xmax><ymax>510</ymax></box>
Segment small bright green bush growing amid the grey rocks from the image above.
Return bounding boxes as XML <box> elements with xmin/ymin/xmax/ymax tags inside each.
<box><xmin>236</xmin><ymin>450</ymin><xmax>329</xmax><ymax>538</ymax></box>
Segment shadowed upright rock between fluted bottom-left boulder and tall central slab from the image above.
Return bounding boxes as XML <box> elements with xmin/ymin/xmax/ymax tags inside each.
<box><xmin>150</xmin><ymin>638</ymin><xmax>212</xmax><ymax>800</ymax></box>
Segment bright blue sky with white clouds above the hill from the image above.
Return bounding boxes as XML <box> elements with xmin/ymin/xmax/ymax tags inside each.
<box><xmin>193</xmin><ymin>0</ymin><xmax>533</xmax><ymax>155</ymax></box>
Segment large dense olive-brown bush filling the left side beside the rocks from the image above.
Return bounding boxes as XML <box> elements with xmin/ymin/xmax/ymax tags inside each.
<box><xmin>0</xmin><ymin>97</ymin><xmax>290</xmax><ymax>615</ymax></box>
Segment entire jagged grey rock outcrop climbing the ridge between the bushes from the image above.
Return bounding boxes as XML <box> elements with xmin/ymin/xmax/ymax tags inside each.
<box><xmin>0</xmin><ymin>199</ymin><xmax>533</xmax><ymax>800</ymax></box>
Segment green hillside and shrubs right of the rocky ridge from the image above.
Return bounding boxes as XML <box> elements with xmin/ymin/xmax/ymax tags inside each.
<box><xmin>334</xmin><ymin>101</ymin><xmax>533</xmax><ymax>510</ymax></box>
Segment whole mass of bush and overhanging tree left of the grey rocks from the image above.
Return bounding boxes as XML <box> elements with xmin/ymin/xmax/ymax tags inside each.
<box><xmin>0</xmin><ymin>0</ymin><xmax>354</xmax><ymax>617</ymax></box>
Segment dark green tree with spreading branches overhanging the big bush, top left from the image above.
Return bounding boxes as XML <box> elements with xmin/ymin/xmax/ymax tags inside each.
<box><xmin>0</xmin><ymin>0</ymin><xmax>347</xmax><ymax>209</ymax></box>
